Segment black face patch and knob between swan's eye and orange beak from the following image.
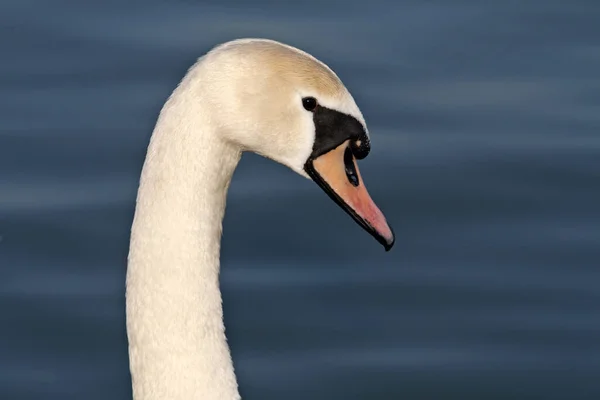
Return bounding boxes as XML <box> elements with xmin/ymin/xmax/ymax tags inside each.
<box><xmin>310</xmin><ymin>105</ymin><xmax>371</xmax><ymax>160</ymax></box>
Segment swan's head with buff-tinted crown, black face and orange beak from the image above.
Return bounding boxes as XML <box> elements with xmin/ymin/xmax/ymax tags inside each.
<box><xmin>198</xmin><ymin>39</ymin><xmax>394</xmax><ymax>251</ymax></box>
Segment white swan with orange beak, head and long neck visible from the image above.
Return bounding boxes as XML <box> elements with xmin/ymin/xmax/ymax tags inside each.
<box><xmin>126</xmin><ymin>39</ymin><xmax>394</xmax><ymax>400</ymax></box>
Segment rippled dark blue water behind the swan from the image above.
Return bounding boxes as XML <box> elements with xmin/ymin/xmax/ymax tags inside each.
<box><xmin>0</xmin><ymin>0</ymin><xmax>600</xmax><ymax>400</ymax></box>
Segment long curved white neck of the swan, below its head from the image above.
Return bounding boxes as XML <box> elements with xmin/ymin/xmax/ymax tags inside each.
<box><xmin>126</xmin><ymin>92</ymin><xmax>240</xmax><ymax>400</ymax></box>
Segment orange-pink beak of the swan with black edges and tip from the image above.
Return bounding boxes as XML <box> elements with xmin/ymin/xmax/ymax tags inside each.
<box><xmin>306</xmin><ymin>140</ymin><xmax>394</xmax><ymax>251</ymax></box>
